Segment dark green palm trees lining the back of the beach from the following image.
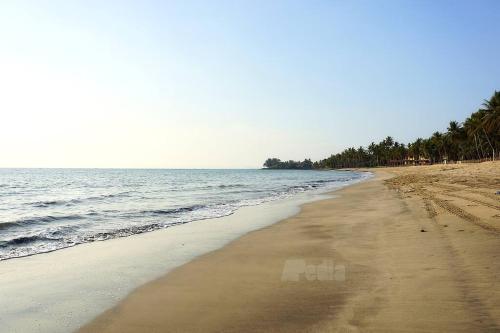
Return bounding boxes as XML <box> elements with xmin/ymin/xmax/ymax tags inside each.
<box><xmin>264</xmin><ymin>91</ymin><xmax>500</xmax><ymax>169</ymax></box>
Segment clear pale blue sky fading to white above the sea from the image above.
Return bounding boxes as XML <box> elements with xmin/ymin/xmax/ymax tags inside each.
<box><xmin>0</xmin><ymin>0</ymin><xmax>500</xmax><ymax>168</ymax></box>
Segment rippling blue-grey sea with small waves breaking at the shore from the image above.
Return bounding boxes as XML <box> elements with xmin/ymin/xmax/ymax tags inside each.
<box><xmin>0</xmin><ymin>169</ymin><xmax>367</xmax><ymax>260</ymax></box>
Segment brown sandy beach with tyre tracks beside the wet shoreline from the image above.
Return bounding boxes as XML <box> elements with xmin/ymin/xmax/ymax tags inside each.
<box><xmin>81</xmin><ymin>162</ymin><xmax>500</xmax><ymax>332</ymax></box>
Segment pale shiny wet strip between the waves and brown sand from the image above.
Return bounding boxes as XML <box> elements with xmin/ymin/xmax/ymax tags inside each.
<box><xmin>0</xmin><ymin>174</ymin><xmax>368</xmax><ymax>333</ymax></box>
